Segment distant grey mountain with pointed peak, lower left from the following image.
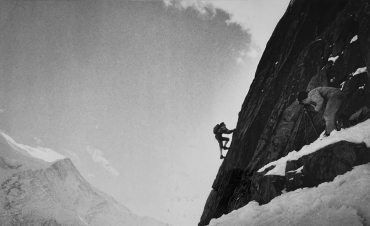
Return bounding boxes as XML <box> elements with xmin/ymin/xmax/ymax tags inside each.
<box><xmin>0</xmin><ymin>135</ymin><xmax>168</xmax><ymax>226</ymax></box>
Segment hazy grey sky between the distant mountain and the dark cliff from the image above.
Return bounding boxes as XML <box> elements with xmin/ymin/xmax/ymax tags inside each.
<box><xmin>0</xmin><ymin>0</ymin><xmax>289</xmax><ymax>226</ymax></box>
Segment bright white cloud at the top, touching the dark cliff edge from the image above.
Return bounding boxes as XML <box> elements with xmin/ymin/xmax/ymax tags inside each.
<box><xmin>163</xmin><ymin>0</ymin><xmax>290</xmax><ymax>55</ymax></box>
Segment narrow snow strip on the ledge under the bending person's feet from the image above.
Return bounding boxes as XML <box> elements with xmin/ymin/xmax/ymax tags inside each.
<box><xmin>258</xmin><ymin>119</ymin><xmax>370</xmax><ymax>176</ymax></box>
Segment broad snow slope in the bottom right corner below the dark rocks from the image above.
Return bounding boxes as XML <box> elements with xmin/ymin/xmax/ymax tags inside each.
<box><xmin>210</xmin><ymin>163</ymin><xmax>370</xmax><ymax>226</ymax></box>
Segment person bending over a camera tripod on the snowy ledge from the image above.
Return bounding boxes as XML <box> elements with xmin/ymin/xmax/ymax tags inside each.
<box><xmin>298</xmin><ymin>87</ymin><xmax>347</xmax><ymax>136</ymax></box>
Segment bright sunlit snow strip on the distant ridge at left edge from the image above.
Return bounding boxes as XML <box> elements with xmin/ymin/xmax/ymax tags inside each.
<box><xmin>0</xmin><ymin>132</ymin><xmax>66</xmax><ymax>162</ymax></box>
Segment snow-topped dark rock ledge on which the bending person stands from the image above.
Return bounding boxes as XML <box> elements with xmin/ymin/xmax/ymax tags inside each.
<box><xmin>240</xmin><ymin>120</ymin><xmax>370</xmax><ymax>210</ymax></box>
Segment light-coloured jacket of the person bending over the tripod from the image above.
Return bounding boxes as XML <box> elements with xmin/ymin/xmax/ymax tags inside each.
<box><xmin>302</xmin><ymin>87</ymin><xmax>344</xmax><ymax>111</ymax></box>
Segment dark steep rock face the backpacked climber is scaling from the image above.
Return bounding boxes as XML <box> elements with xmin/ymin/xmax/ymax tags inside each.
<box><xmin>199</xmin><ymin>0</ymin><xmax>370</xmax><ymax>225</ymax></box>
